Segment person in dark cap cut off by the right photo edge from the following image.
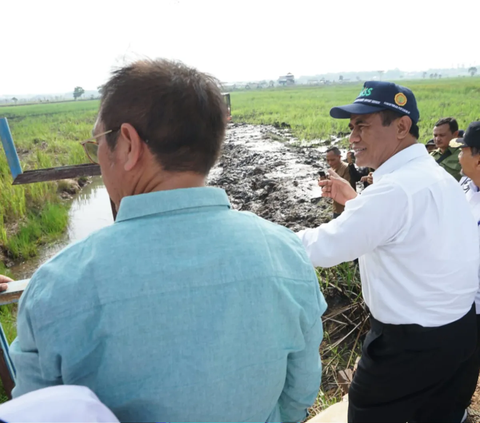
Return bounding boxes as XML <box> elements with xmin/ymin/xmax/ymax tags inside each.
<box><xmin>456</xmin><ymin>122</ymin><xmax>480</xmax><ymax>422</ymax></box>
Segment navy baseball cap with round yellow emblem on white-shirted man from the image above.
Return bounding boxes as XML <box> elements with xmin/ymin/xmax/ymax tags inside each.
<box><xmin>330</xmin><ymin>81</ymin><xmax>420</xmax><ymax>123</ymax></box>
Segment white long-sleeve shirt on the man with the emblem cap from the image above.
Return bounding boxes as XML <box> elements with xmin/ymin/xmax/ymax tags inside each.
<box><xmin>298</xmin><ymin>144</ymin><xmax>479</xmax><ymax>327</ymax></box>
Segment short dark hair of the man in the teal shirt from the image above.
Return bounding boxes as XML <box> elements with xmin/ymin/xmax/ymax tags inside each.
<box><xmin>100</xmin><ymin>59</ymin><xmax>227</xmax><ymax>175</ymax></box>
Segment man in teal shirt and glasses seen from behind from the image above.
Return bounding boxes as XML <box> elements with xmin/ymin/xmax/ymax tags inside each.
<box><xmin>11</xmin><ymin>60</ymin><xmax>326</xmax><ymax>422</ymax></box>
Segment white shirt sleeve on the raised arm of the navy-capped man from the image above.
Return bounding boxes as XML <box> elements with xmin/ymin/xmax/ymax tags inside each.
<box><xmin>297</xmin><ymin>183</ymin><xmax>410</xmax><ymax>267</ymax></box>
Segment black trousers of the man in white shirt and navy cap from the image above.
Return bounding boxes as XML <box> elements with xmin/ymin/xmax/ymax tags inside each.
<box><xmin>348</xmin><ymin>307</ymin><xmax>478</xmax><ymax>423</ymax></box>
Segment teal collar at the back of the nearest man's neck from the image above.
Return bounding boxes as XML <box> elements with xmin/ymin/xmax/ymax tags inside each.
<box><xmin>116</xmin><ymin>187</ymin><xmax>231</xmax><ymax>222</ymax></box>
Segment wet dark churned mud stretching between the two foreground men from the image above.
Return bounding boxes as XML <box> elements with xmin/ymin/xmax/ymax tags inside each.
<box><xmin>209</xmin><ymin>124</ymin><xmax>336</xmax><ymax>231</ymax></box>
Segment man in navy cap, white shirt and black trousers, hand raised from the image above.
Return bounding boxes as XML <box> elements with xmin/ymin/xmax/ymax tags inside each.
<box><xmin>298</xmin><ymin>81</ymin><xmax>479</xmax><ymax>422</ymax></box>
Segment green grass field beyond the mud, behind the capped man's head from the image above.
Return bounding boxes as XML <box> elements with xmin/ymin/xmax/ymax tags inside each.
<box><xmin>231</xmin><ymin>78</ymin><xmax>480</xmax><ymax>142</ymax></box>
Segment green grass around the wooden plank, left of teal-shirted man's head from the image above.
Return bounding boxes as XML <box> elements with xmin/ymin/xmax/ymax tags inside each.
<box><xmin>0</xmin><ymin>101</ymin><xmax>98</xmax><ymax>259</ymax></box>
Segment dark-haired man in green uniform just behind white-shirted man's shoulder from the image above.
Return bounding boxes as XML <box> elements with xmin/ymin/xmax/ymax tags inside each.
<box><xmin>430</xmin><ymin>117</ymin><xmax>461</xmax><ymax>181</ymax></box>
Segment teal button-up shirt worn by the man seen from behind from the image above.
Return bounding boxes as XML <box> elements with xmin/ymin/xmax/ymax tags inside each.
<box><xmin>10</xmin><ymin>188</ymin><xmax>326</xmax><ymax>422</ymax></box>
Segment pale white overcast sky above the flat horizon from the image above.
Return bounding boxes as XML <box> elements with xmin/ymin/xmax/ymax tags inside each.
<box><xmin>0</xmin><ymin>0</ymin><xmax>480</xmax><ymax>96</ymax></box>
